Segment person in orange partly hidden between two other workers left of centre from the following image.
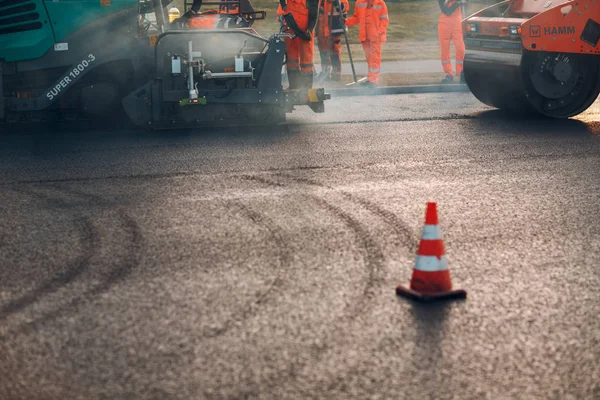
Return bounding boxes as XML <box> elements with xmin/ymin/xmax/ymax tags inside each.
<box><xmin>317</xmin><ymin>0</ymin><xmax>350</xmax><ymax>81</ymax></box>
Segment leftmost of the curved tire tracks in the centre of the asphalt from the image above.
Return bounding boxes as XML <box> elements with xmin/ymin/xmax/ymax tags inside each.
<box><xmin>202</xmin><ymin>201</ymin><xmax>292</xmax><ymax>338</ymax></box>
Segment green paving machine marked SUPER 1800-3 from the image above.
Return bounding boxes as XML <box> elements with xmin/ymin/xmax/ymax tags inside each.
<box><xmin>0</xmin><ymin>0</ymin><xmax>329</xmax><ymax>129</ymax></box>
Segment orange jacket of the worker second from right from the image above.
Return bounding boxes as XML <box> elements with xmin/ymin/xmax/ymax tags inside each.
<box><xmin>346</xmin><ymin>0</ymin><xmax>390</xmax><ymax>42</ymax></box>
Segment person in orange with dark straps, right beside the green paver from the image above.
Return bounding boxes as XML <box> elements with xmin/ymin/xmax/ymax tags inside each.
<box><xmin>277</xmin><ymin>0</ymin><xmax>319</xmax><ymax>89</ymax></box>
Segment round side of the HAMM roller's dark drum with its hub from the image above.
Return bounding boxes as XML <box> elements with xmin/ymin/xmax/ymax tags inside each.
<box><xmin>521</xmin><ymin>50</ymin><xmax>600</xmax><ymax>118</ymax></box>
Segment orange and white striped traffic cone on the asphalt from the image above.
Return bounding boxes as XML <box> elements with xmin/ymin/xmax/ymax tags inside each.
<box><xmin>396</xmin><ymin>203</ymin><xmax>467</xmax><ymax>301</ymax></box>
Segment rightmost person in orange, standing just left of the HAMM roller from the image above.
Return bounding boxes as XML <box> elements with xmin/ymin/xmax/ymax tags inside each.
<box><xmin>438</xmin><ymin>0</ymin><xmax>465</xmax><ymax>83</ymax></box>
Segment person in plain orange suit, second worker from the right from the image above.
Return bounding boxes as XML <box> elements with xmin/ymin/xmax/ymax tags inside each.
<box><xmin>346</xmin><ymin>0</ymin><xmax>389</xmax><ymax>87</ymax></box>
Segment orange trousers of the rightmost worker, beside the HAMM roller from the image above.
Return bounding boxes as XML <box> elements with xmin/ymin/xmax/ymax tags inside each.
<box><xmin>438</xmin><ymin>8</ymin><xmax>465</xmax><ymax>75</ymax></box>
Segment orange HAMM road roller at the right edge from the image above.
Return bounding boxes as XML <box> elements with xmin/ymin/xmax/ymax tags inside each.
<box><xmin>463</xmin><ymin>0</ymin><xmax>600</xmax><ymax>118</ymax></box>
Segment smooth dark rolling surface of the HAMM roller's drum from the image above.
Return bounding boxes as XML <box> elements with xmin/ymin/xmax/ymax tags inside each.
<box><xmin>464</xmin><ymin>52</ymin><xmax>531</xmax><ymax>112</ymax></box>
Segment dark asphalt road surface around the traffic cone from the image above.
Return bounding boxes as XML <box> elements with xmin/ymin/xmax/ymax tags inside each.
<box><xmin>0</xmin><ymin>93</ymin><xmax>600</xmax><ymax>400</ymax></box>
